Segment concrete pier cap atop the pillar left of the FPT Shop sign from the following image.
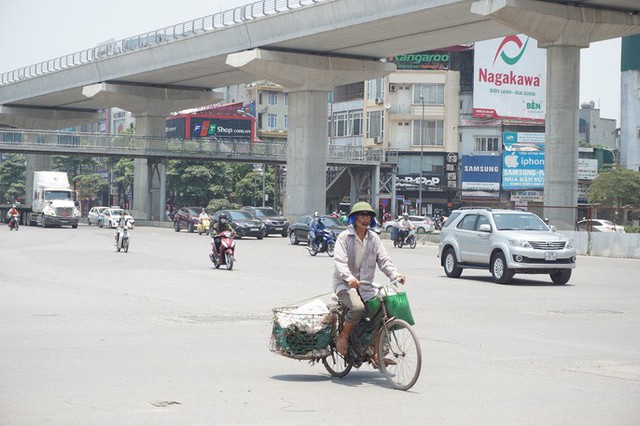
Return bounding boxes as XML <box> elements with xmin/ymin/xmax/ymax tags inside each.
<box><xmin>82</xmin><ymin>83</ymin><xmax>223</xmax><ymax>116</ymax></box>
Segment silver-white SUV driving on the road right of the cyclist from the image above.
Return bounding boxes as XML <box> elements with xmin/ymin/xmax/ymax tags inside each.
<box><xmin>438</xmin><ymin>208</ymin><xmax>576</xmax><ymax>284</ymax></box>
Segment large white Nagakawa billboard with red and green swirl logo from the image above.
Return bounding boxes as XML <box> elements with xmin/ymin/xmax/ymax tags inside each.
<box><xmin>473</xmin><ymin>34</ymin><xmax>547</xmax><ymax>121</ymax></box>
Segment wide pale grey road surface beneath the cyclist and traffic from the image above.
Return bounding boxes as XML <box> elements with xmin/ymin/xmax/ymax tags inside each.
<box><xmin>0</xmin><ymin>225</ymin><xmax>640</xmax><ymax>426</ymax></box>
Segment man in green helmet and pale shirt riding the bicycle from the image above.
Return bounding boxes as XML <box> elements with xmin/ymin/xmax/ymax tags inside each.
<box><xmin>333</xmin><ymin>201</ymin><xmax>405</xmax><ymax>363</ymax></box>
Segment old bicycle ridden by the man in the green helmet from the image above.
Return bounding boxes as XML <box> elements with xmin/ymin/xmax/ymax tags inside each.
<box><xmin>322</xmin><ymin>281</ymin><xmax>422</xmax><ymax>390</ymax></box>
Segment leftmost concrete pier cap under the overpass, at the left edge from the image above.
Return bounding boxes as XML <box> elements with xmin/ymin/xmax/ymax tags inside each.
<box><xmin>0</xmin><ymin>105</ymin><xmax>99</xmax><ymax>130</ymax></box>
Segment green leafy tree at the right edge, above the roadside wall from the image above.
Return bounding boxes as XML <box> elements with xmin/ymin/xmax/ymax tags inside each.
<box><xmin>587</xmin><ymin>166</ymin><xmax>640</xmax><ymax>207</ymax></box>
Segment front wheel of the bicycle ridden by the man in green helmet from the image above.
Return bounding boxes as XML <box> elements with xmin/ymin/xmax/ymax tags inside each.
<box><xmin>378</xmin><ymin>319</ymin><xmax>422</xmax><ymax>390</ymax></box>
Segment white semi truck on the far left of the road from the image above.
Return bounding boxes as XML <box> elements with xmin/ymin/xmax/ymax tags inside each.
<box><xmin>29</xmin><ymin>171</ymin><xmax>80</xmax><ymax>228</ymax></box>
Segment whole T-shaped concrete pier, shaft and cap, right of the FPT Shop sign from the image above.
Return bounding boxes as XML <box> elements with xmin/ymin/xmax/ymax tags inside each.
<box><xmin>226</xmin><ymin>49</ymin><xmax>395</xmax><ymax>218</ymax></box>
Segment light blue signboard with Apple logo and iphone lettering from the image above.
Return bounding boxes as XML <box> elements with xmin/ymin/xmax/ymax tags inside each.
<box><xmin>502</xmin><ymin>151</ymin><xmax>544</xmax><ymax>189</ymax></box>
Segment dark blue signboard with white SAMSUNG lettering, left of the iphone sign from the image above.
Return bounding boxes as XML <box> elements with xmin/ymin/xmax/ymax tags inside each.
<box><xmin>460</xmin><ymin>155</ymin><xmax>502</xmax><ymax>191</ymax></box>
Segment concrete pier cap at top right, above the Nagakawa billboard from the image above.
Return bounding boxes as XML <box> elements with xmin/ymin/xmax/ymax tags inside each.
<box><xmin>471</xmin><ymin>0</ymin><xmax>640</xmax><ymax>47</ymax></box>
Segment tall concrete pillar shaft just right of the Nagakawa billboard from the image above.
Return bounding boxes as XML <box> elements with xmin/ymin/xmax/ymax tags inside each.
<box><xmin>544</xmin><ymin>46</ymin><xmax>580</xmax><ymax>230</ymax></box>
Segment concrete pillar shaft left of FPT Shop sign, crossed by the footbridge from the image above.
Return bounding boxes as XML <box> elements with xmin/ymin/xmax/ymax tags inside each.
<box><xmin>131</xmin><ymin>114</ymin><xmax>167</xmax><ymax>220</ymax></box>
